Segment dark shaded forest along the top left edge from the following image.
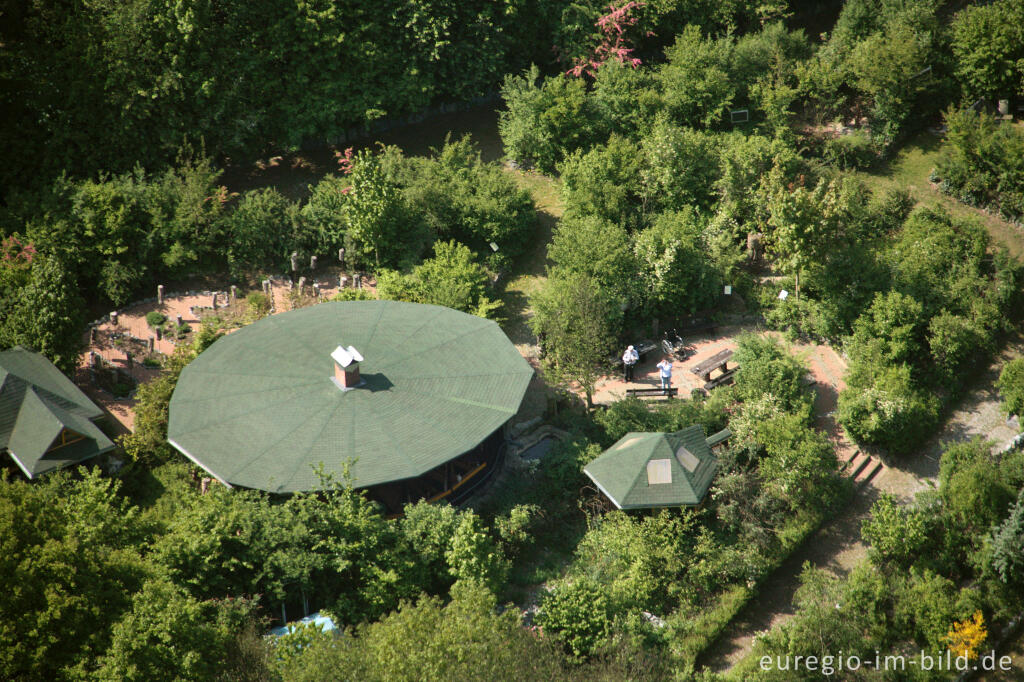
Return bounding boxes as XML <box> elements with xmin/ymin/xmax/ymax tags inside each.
<box><xmin>0</xmin><ymin>0</ymin><xmax>785</xmax><ymax>193</ymax></box>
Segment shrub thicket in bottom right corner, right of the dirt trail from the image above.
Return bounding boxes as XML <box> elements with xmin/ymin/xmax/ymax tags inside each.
<box><xmin>751</xmin><ymin>440</ymin><xmax>1024</xmax><ymax>680</ymax></box>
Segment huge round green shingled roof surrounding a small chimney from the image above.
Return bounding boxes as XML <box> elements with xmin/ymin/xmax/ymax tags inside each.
<box><xmin>167</xmin><ymin>301</ymin><xmax>534</xmax><ymax>493</ymax></box>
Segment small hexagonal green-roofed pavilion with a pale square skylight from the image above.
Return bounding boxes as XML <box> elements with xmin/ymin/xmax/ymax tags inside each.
<box><xmin>584</xmin><ymin>425</ymin><xmax>718</xmax><ymax>509</ymax></box>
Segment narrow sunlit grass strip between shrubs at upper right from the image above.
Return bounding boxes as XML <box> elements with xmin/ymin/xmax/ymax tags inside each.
<box><xmin>856</xmin><ymin>132</ymin><xmax>1024</xmax><ymax>258</ymax></box>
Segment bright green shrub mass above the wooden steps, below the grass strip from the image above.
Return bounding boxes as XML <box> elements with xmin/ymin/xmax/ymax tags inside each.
<box><xmin>840</xmin><ymin>210</ymin><xmax>1021</xmax><ymax>453</ymax></box>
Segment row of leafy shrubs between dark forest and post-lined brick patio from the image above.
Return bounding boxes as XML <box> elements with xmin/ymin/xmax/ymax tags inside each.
<box><xmin>0</xmin><ymin>139</ymin><xmax>536</xmax><ymax>327</ymax></box>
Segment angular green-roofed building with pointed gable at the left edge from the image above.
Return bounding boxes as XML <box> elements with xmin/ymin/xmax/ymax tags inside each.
<box><xmin>0</xmin><ymin>346</ymin><xmax>114</xmax><ymax>478</ymax></box>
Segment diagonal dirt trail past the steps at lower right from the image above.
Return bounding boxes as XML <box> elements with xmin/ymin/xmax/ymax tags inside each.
<box><xmin>698</xmin><ymin>335</ymin><xmax>1024</xmax><ymax>672</ymax></box>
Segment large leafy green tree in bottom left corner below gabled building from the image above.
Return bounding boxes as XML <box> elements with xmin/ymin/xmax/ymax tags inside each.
<box><xmin>0</xmin><ymin>469</ymin><xmax>148</xmax><ymax>680</ymax></box>
